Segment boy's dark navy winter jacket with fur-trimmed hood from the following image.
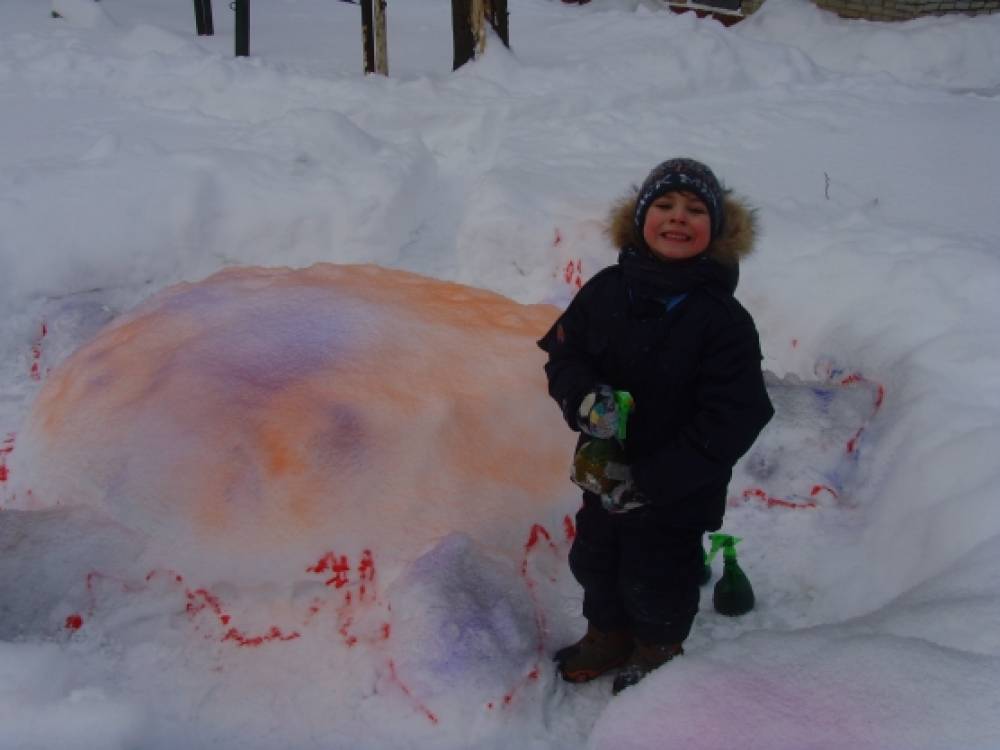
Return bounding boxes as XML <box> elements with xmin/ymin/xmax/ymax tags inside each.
<box><xmin>538</xmin><ymin>189</ymin><xmax>774</xmax><ymax>530</ymax></box>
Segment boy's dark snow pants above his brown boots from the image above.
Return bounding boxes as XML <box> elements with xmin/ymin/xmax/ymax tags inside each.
<box><xmin>569</xmin><ymin>492</ymin><xmax>705</xmax><ymax>644</ymax></box>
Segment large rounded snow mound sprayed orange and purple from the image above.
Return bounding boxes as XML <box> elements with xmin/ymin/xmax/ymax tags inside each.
<box><xmin>11</xmin><ymin>264</ymin><xmax>574</xmax><ymax>583</ymax></box>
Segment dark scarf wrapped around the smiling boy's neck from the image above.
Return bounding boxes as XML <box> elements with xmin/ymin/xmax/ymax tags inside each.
<box><xmin>618</xmin><ymin>247</ymin><xmax>740</xmax><ymax>300</ymax></box>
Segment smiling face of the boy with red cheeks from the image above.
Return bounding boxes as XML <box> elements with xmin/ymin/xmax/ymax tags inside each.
<box><xmin>642</xmin><ymin>192</ymin><xmax>712</xmax><ymax>260</ymax></box>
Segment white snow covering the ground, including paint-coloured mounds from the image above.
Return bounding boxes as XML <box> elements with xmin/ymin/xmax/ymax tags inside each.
<box><xmin>0</xmin><ymin>0</ymin><xmax>1000</xmax><ymax>750</ymax></box>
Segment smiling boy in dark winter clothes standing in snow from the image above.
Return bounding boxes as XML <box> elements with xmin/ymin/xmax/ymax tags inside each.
<box><xmin>539</xmin><ymin>159</ymin><xmax>774</xmax><ymax>693</ymax></box>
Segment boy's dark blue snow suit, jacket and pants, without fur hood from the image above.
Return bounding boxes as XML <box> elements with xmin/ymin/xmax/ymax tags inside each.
<box><xmin>538</xmin><ymin>209</ymin><xmax>774</xmax><ymax>644</ymax></box>
